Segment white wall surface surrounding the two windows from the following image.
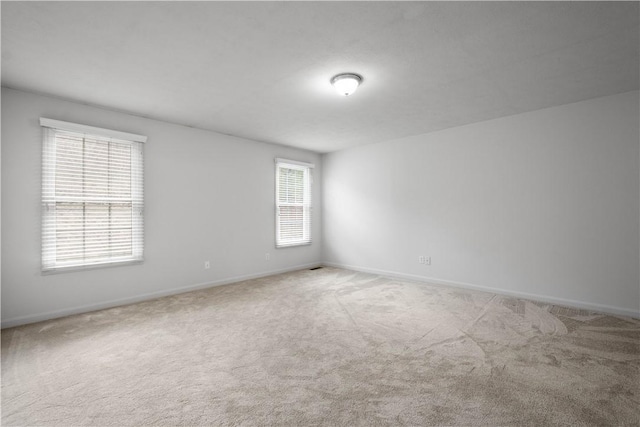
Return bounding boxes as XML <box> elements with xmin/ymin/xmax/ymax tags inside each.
<box><xmin>1</xmin><ymin>89</ymin><xmax>322</xmax><ymax>327</ymax></box>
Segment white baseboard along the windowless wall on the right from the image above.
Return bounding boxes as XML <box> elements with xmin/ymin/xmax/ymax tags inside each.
<box><xmin>322</xmin><ymin>262</ymin><xmax>640</xmax><ymax>319</ymax></box>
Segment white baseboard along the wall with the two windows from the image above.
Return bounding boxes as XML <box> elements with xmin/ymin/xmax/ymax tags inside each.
<box><xmin>1</xmin><ymin>262</ymin><xmax>322</xmax><ymax>329</ymax></box>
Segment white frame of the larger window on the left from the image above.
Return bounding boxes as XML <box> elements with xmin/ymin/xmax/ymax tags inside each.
<box><xmin>40</xmin><ymin>118</ymin><xmax>147</xmax><ymax>274</ymax></box>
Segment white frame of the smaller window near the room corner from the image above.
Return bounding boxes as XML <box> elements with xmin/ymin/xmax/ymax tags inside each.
<box><xmin>275</xmin><ymin>158</ymin><xmax>314</xmax><ymax>249</ymax></box>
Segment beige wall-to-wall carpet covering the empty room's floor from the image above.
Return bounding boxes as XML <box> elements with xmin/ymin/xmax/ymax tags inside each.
<box><xmin>2</xmin><ymin>268</ymin><xmax>640</xmax><ymax>426</ymax></box>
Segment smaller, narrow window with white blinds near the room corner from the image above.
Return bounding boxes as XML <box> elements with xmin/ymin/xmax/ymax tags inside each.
<box><xmin>276</xmin><ymin>159</ymin><xmax>313</xmax><ymax>248</ymax></box>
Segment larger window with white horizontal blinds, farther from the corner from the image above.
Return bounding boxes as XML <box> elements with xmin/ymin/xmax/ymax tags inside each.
<box><xmin>40</xmin><ymin>118</ymin><xmax>147</xmax><ymax>272</ymax></box>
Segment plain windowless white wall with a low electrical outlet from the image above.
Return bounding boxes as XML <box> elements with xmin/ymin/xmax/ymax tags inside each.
<box><xmin>323</xmin><ymin>91</ymin><xmax>640</xmax><ymax>316</ymax></box>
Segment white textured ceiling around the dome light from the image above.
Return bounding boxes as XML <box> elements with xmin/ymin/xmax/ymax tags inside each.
<box><xmin>1</xmin><ymin>2</ymin><xmax>640</xmax><ymax>152</ymax></box>
